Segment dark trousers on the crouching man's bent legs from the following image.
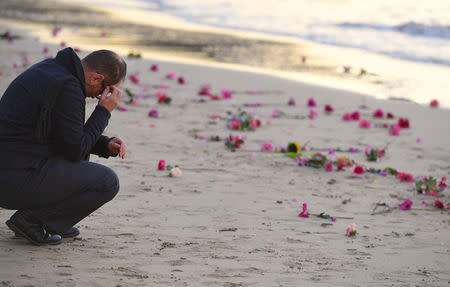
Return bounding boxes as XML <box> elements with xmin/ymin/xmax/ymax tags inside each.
<box><xmin>0</xmin><ymin>158</ymin><xmax>119</xmax><ymax>234</ymax></box>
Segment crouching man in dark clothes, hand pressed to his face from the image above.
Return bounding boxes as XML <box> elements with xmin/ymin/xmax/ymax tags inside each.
<box><xmin>0</xmin><ymin>48</ymin><xmax>126</xmax><ymax>245</ymax></box>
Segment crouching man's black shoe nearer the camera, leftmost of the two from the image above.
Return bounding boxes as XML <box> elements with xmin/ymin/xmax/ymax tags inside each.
<box><xmin>6</xmin><ymin>212</ymin><xmax>62</xmax><ymax>245</ymax></box>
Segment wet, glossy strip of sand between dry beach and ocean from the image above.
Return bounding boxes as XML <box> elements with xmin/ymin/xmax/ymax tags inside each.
<box><xmin>0</xmin><ymin>1</ymin><xmax>450</xmax><ymax>108</ymax></box>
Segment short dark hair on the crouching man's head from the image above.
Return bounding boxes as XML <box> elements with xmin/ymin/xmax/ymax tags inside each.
<box><xmin>81</xmin><ymin>50</ymin><xmax>127</xmax><ymax>86</ymax></box>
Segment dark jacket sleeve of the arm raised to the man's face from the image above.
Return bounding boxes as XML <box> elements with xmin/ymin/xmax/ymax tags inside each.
<box><xmin>54</xmin><ymin>82</ymin><xmax>111</xmax><ymax>162</ymax></box>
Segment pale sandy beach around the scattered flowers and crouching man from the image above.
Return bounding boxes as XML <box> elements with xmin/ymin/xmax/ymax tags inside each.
<box><xmin>0</xmin><ymin>1</ymin><xmax>450</xmax><ymax>287</ymax></box>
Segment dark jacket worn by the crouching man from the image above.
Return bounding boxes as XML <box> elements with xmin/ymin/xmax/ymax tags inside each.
<box><xmin>0</xmin><ymin>48</ymin><xmax>113</xmax><ymax>168</ymax></box>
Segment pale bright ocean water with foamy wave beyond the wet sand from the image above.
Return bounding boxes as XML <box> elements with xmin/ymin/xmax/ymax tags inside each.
<box><xmin>140</xmin><ymin>0</ymin><xmax>450</xmax><ymax>66</ymax></box>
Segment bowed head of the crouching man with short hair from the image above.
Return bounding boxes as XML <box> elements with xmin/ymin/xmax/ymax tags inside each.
<box><xmin>81</xmin><ymin>50</ymin><xmax>127</xmax><ymax>98</ymax></box>
